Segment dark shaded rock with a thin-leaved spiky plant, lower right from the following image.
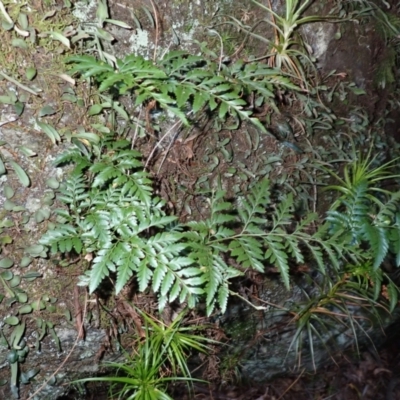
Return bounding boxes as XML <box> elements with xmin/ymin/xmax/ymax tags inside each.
<box><xmin>220</xmin><ymin>278</ymin><xmax>394</xmax><ymax>383</ymax></box>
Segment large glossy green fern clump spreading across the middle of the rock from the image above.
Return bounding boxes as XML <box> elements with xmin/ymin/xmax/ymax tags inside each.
<box><xmin>40</xmin><ymin>125</ymin><xmax>366</xmax><ymax>315</ymax></box>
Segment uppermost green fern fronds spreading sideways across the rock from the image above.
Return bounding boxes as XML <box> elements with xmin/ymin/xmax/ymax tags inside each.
<box><xmin>68</xmin><ymin>51</ymin><xmax>300</xmax><ymax>132</ymax></box>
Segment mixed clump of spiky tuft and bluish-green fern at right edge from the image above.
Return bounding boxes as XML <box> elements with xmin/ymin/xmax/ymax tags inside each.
<box><xmin>327</xmin><ymin>146</ymin><xmax>400</xmax><ymax>309</ymax></box>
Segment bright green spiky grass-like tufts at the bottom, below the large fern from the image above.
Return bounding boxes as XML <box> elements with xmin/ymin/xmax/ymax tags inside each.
<box><xmin>77</xmin><ymin>312</ymin><xmax>213</xmax><ymax>400</ymax></box>
